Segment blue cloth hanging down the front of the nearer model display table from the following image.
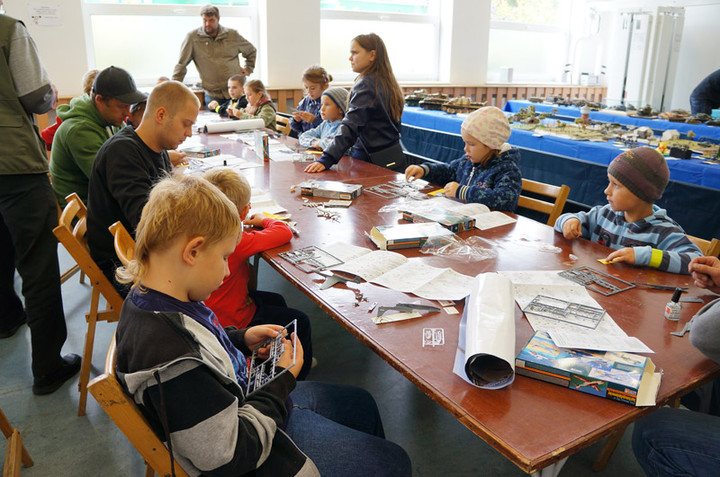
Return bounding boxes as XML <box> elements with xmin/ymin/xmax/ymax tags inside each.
<box><xmin>402</xmin><ymin>106</ymin><xmax>720</xmax><ymax>239</ymax></box>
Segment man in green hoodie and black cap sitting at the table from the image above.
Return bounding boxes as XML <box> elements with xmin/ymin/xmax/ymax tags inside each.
<box><xmin>50</xmin><ymin>66</ymin><xmax>147</xmax><ymax>207</ymax></box>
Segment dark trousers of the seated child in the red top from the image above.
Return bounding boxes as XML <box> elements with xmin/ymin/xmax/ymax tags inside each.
<box><xmin>248</xmin><ymin>290</ymin><xmax>312</xmax><ymax>379</ymax></box>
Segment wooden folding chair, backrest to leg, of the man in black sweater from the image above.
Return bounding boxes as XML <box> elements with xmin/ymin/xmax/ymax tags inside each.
<box><xmin>53</xmin><ymin>194</ymin><xmax>123</xmax><ymax>416</ymax></box>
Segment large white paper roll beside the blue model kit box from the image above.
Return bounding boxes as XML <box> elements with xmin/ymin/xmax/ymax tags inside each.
<box><xmin>453</xmin><ymin>273</ymin><xmax>515</xmax><ymax>389</ymax></box>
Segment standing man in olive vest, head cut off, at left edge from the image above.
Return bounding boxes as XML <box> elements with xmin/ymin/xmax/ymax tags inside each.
<box><xmin>0</xmin><ymin>7</ymin><xmax>80</xmax><ymax>394</ymax></box>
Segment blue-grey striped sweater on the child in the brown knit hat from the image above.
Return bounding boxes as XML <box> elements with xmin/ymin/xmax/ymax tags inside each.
<box><xmin>555</xmin><ymin>204</ymin><xmax>702</xmax><ymax>274</ymax></box>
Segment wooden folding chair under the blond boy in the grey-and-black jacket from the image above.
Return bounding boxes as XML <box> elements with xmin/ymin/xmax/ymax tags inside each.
<box><xmin>88</xmin><ymin>336</ymin><xmax>187</xmax><ymax>477</ymax></box>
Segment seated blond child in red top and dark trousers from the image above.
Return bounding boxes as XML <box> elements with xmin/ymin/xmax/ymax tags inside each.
<box><xmin>203</xmin><ymin>168</ymin><xmax>313</xmax><ymax>379</ymax></box>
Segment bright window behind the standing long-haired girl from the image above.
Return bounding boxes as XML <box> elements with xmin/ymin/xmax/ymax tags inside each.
<box><xmin>320</xmin><ymin>0</ymin><xmax>440</xmax><ymax>81</ymax></box>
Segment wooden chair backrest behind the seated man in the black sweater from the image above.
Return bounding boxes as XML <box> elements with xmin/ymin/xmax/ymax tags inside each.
<box><xmin>53</xmin><ymin>194</ymin><xmax>123</xmax><ymax>312</ymax></box>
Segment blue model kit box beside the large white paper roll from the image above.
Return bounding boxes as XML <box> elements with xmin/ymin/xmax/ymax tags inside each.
<box><xmin>515</xmin><ymin>331</ymin><xmax>662</xmax><ymax>406</ymax></box>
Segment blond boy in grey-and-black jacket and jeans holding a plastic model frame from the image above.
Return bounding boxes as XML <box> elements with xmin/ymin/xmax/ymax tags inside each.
<box><xmin>115</xmin><ymin>176</ymin><xmax>412</xmax><ymax>477</ymax></box>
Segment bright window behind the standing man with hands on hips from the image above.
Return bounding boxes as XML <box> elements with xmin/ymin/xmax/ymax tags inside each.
<box><xmin>83</xmin><ymin>0</ymin><xmax>259</xmax><ymax>86</ymax></box>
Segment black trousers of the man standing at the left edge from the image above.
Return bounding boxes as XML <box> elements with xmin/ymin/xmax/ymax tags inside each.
<box><xmin>0</xmin><ymin>174</ymin><xmax>67</xmax><ymax>377</ymax></box>
